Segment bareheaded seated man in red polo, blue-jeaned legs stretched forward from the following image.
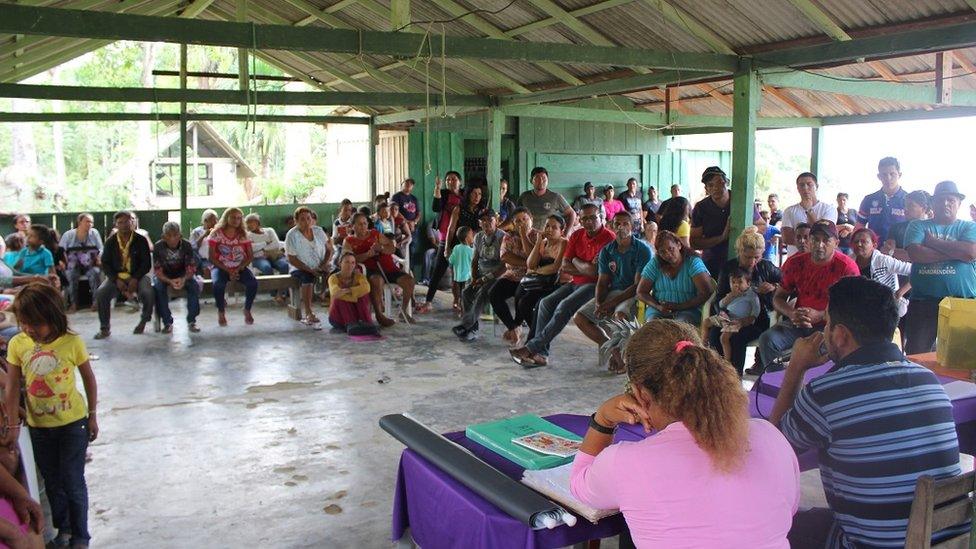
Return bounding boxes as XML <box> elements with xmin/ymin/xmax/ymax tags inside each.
<box><xmin>509</xmin><ymin>204</ymin><xmax>615</xmax><ymax>368</ymax></box>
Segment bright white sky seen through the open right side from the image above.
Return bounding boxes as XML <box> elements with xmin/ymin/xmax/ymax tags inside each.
<box><xmin>683</xmin><ymin>117</ymin><xmax>976</xmax><ymax>213</ymax></box>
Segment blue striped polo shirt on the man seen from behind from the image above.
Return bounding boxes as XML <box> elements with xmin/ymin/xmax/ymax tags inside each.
<box><xmin>780</xmin><ymin>343</ymin><xmax>960</xmax><ymax>547</ymax></box>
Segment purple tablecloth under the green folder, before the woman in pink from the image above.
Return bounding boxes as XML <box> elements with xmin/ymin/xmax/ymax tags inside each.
<box><xmin>392</xmin><ymin>414</ymin><xmax>646</xmax><ymax>549</ymax></box>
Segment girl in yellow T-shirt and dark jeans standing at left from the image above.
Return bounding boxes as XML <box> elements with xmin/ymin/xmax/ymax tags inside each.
<box><xmin>4</xmin><ymin>283</ymin><xmax>98</xmax><ymax>548</ymax></box>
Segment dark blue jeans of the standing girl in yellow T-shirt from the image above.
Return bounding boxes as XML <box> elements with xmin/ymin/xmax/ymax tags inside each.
<box><xmin>30</xmin><ymin>417</ymin><xmax>91</xmax><ymax>544</ymax></box>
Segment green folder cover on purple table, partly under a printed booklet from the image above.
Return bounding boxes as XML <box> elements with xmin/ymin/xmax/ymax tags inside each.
<box><xmin>464</xmin><ymin>414</ymin><xmax>583</xmax><ymax>470</ymax></box>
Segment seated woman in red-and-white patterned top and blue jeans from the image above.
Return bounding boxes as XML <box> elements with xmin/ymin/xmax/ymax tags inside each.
<box><xmin>207</xmin><ymin>208</ymin><xmax>258</xmax><ymax>326</ymax></box>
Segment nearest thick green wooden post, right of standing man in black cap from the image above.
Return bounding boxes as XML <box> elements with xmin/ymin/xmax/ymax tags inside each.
<box><xmin>729</xmin><ymin>60</ymin><xmax>760</xmax><ymax>257</ymax></box>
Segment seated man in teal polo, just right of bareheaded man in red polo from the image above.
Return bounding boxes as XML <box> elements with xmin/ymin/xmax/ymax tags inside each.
<box><xmin>573</xmin><ymin>211</ymin><xmax>653</xmax><ymax>373</ymax></box>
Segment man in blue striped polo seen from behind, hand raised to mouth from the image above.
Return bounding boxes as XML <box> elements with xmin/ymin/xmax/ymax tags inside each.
<box><xmin>769</xmin><ymin>277</ymin><xmax>968</xmax><ymax>547</ymax></box>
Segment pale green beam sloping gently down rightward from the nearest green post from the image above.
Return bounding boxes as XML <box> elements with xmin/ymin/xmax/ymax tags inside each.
<box><xmin>761</xmin><ymin>71</ymin><xmax>976</xmax><ymax>107</ymax></box>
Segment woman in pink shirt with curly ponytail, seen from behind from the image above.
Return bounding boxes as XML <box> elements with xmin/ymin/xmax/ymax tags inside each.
<box><xmin>571</xmin><ymin>320</ymin><xmax>800</xmax><ymax>549</ymax></box>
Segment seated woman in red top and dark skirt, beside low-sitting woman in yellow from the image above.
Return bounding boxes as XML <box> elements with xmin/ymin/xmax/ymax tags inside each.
<box><xmin>342</xmin><ymin>213</ymin><xmax>415</xmax><ymax>327</ymax></box>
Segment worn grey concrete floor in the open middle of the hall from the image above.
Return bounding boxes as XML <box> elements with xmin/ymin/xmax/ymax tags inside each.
<box><xmin>78</xmin><ymin>293</ymin><xmax>640</xmax><ymax>547</ymax></box>
